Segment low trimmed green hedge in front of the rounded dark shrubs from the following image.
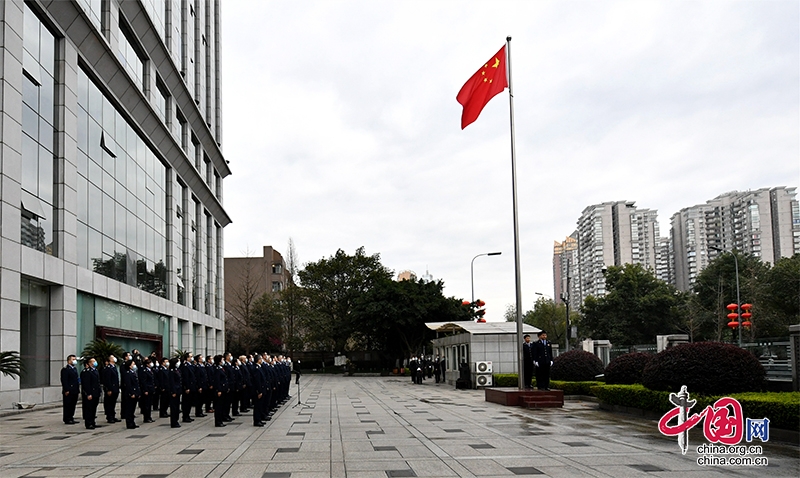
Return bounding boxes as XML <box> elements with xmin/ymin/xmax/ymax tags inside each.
<box><xmin>591</xmin><ymin>384</ymin><xmax>800</xmax><ymax>431</ymax></box>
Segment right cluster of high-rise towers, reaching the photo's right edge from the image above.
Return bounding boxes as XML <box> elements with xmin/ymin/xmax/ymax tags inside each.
<box><xmin>671</xmin><ymin>186</ymin><xmax>800</xmax><ymax>290</ymax></box>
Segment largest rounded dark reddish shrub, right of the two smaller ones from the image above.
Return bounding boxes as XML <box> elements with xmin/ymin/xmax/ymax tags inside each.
<box><xmin>642</xmin><ymin>342</ymin><xmax>766</xmax><ymax>395</ymax></box>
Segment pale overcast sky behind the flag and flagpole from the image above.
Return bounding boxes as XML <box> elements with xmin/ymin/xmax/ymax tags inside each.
<box><xmin>222</xmin><ymin>0</ymin><xmax>800</xmax><ymax>320</ymax></box>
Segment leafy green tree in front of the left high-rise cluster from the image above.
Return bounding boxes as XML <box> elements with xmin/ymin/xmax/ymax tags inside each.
<box><xmin>581</xmin><ymin>264</ymin><xmax>681</xmax><ymax>346</ymax></box>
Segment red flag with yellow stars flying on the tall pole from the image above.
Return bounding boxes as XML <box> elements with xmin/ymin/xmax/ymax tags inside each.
<box><xmin>456</xmin><ymin>45</ymin><xmax>508</xmax><ymax>129</ymax></box>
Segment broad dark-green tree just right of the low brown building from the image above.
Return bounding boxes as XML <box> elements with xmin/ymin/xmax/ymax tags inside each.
<box><xmin>298</xmin><ymin>247</ymin><xmax>392</xmax><ymax>352</ymax></box>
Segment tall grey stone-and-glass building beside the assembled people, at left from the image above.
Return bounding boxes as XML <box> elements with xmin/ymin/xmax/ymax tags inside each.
<box><xmin>0</xmin><ymin>0</ymin><xmax>230</xmax><ymax>404</ymax></box>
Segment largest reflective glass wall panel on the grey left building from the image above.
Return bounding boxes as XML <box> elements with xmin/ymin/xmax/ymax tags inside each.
<box><xmin>76</xmin><ymin>70</ymin><xmax>167</xmax><ymax>297</ymax></box>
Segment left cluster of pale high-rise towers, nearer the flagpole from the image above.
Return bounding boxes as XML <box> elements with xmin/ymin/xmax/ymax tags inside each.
<box><xmin>553</xmin><ymin>201</ymin><xmax>663</xmax><ymax>307</ymax></box>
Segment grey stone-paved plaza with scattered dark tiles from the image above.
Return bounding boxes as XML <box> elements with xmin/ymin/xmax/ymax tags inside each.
<box><xmin>0</xmin><ymin>375</ymin><xmax>800</xmax><ymax>478</ymax></box>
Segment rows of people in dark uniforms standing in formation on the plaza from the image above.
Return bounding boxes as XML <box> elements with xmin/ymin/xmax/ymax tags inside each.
<box><xmin>61</xmin><ymin>350</ymin><xmax>299</xmax><ymax>430</ymax></box>
